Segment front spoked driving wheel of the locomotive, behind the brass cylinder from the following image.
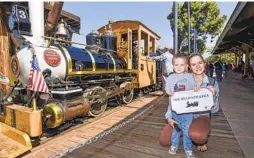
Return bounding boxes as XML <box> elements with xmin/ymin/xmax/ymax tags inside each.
<box><xmin>84</xmin><ymin>86</ymin><xmax>107</xmax><ymax>117</ymax></box>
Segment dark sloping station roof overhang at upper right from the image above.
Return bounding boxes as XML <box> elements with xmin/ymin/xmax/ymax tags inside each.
<box><xmin>212</xmin><ymin>2</ymin><xmax>254</xmax><ymax>54</ymax></box>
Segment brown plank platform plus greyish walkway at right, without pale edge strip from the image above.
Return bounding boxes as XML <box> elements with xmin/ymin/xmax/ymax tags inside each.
<box><xmin>64</xmin><ymin>74</ymin><xmax>254</xmax><ymax>158</ymax></box>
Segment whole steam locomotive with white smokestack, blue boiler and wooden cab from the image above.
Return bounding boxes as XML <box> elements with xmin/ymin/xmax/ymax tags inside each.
<box><xmin>0</xmin><ymin>2</ymin><xmax>162</xmax><ymax>157</ymax></box>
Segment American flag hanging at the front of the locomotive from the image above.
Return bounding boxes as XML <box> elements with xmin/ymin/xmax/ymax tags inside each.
<box><xmin>29</xmin><ymin>55</ymin><xmax>49</xmax><ymax>93</ymax></box>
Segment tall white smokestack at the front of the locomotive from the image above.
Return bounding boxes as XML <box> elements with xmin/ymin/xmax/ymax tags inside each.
<box><xmin>29</xmin><ymin>1</ymin><xmax>44</xmax><ymax>44</ymax></box>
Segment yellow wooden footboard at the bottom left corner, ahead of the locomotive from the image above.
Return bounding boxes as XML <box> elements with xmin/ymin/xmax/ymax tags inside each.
<box><xmin>0</xmin><ymin>122</ymin><xmax>32</xmax><ymax>158</ymax></box>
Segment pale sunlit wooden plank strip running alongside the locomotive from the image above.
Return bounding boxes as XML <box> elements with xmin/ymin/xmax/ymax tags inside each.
<box><xmin>22</xmin><ymin>91</ymin><xmax>162</xmax><ymax>158</ymax></box>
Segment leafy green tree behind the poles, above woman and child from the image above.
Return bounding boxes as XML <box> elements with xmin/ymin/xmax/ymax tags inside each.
<box><xmin>167</xmin><ymin>2</ymin><xmax>227</xmax><ymax>54</ymax></box>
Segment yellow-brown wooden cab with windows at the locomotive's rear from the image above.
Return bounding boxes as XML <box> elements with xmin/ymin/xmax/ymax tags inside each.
<box><xmin>98</xmin><ymin>20</ymin><xmax>160</xmax><ymax>89</ymax></box>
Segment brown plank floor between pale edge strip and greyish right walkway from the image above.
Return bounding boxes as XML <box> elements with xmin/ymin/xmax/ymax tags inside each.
<box><xmin>64</xmin><ymin>97</ymin><xmax>244</xmax><ymax>158</ymax></box>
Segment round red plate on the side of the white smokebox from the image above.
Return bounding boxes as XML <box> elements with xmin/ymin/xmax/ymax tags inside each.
<box><xmin>44</xmin><ymin>49</ymin><xmax>61</xmax><ymax>67</ymax></box>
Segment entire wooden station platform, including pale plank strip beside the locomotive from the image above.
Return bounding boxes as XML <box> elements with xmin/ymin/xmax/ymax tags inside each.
<box><xmin>22</xmin><ymin>75</ymin><xmax>254</xmax><ymax>158</ymax></box>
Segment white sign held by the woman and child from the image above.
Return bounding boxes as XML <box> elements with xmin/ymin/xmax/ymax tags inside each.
<box><xmin>171</xmin><ymin>88</ymin><xmax>214</xmax><ymax>114</ymax></box>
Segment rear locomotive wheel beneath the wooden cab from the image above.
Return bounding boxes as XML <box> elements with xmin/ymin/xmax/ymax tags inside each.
<box><xmin>120</xmin><ymin>82</ymin><xmax>134</xmax><ymax>104</ymax></box>
